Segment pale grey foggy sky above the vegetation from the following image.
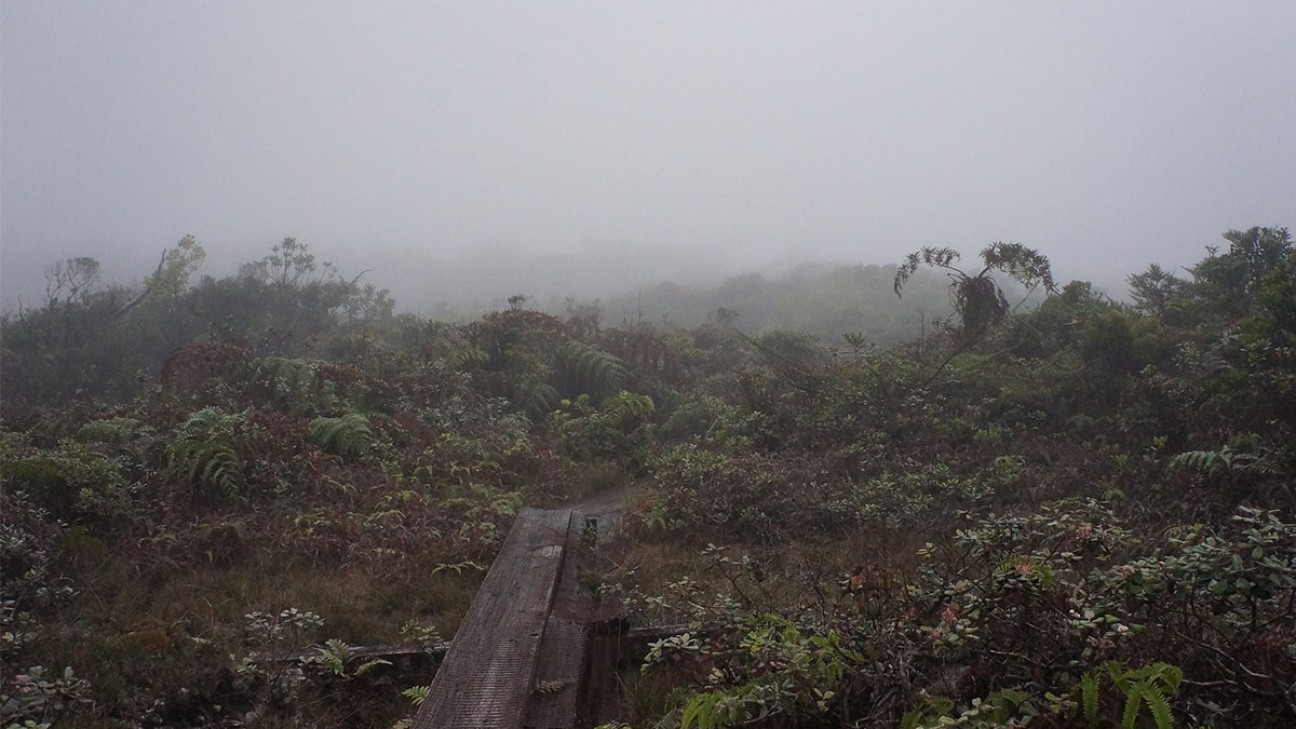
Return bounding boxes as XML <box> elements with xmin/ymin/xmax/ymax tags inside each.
<box><xmin>0</xmin><ymin>0</ymin><xmax>1296</xmax><ymax>307</ymax></box>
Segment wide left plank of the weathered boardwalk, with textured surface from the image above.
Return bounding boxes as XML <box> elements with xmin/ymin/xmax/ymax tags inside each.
<box><xmin>415</xmin><ymin>508</ymin><xmax>572</xmax><ymax>729</ymax></box>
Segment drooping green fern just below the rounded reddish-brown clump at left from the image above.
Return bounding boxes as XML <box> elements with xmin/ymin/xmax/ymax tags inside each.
<box><xmin>167</xmin><ymin>407</ymin><xmax>246</xmax><ymax>498</ymax></box>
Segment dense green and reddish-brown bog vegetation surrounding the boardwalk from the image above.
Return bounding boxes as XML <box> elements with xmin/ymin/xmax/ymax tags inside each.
<box><xmin>0</xmin><ymin>228</ymin><xmax>1296</xmax><ymax>729</ymax></box>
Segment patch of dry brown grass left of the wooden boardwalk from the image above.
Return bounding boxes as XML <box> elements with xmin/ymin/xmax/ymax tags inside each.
<box><xmin>43</xmin><ymin>542</ymin><xmax>482</xmax><ymax>726</ymax></box>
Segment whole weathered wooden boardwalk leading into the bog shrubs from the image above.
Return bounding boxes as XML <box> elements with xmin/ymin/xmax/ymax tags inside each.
<box><xmin>413</xmin><ymin>508</ymin><xmax>623</xmax><ymax>729</ymax></box>
